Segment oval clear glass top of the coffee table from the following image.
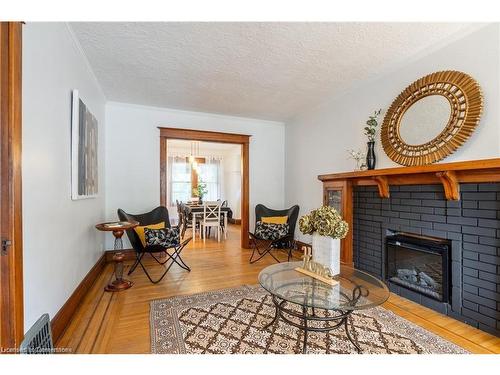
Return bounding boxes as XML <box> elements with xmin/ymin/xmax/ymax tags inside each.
<box><xmin>259</xmin><ymin>262</ymin><xmax>389</xmax><ymax>311</ymax></box>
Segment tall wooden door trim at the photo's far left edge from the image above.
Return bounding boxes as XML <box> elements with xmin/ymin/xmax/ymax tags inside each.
<box><xmin>0</xmin><ymin>22</ymin><xmax>24</xmax><ymax>348</ymax></box>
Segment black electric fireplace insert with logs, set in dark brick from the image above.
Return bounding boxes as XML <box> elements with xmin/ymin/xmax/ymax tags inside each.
<box><xmin>385</xmin><ymin>231</ymin><xmax>451</xmax><ymax>302</ymax></box>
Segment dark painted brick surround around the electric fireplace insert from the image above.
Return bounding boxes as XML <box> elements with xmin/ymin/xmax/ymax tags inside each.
<box><xmin>353</xmin><ymin>183</ymin><xmax>500</xmax><ymax>336</ymax></box>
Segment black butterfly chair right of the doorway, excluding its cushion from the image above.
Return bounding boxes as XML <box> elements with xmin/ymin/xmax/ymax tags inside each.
<box><xmin>249</xmin><ymin>204</ymin><xmax>299</xmax><ymax>264</ymax></box>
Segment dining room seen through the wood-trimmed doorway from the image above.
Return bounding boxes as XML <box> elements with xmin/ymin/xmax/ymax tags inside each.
<box><xmin>165</xmin><ymin>139</ymin><xmax>242</xmax><ymax>243</ymax></box>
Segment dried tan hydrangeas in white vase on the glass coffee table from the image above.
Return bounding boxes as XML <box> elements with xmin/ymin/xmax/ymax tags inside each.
<box><xmin>299</xmin><ymin>206</ymin><xmax>349</xmax><ymax>275</ymax></box>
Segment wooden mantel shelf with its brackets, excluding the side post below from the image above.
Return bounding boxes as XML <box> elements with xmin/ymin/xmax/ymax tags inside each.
<box><xmin>318</xmin><ymin>158</ymin><xmax>500</xmax><ymax>200</ymax></box>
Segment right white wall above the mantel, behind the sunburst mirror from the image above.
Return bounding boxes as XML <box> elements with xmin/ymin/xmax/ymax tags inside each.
<box><xmin>285</xmin><ymin>24</ymin><xmax>500</xmax><ymax>242</ymax></box>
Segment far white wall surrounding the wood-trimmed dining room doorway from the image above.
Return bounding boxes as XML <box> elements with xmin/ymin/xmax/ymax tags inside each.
<box><xmin>106</xmin><ymin>103</ymin><xmax>285</xmax><ymax>250</ymax></box>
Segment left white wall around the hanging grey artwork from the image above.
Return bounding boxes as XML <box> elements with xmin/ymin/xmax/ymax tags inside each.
<box><xmin>22</xmin><ymin>23</ymin><xmax>105</xmax><ymax>330</ymax></box>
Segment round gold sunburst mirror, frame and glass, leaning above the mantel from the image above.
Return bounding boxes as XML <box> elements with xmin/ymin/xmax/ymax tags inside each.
<box><xmin>381</xmin><ymin>71</ymin><xmax>483</xmax><ymax>166</ymax></box>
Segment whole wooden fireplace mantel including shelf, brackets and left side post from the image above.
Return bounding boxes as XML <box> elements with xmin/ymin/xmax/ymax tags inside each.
<box><xmin>318</xmin><ymin>158</ymin><xmax>500</xmax><ymax>263</ymax></box>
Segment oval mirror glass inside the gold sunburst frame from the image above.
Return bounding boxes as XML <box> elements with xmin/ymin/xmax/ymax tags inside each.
<box><xmin>399</xmin><ymin>95</ymin><xmax>451</xmax><ymax>145</ymax></box>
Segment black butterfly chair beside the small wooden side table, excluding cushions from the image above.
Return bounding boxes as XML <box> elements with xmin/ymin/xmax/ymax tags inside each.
<box><xmin>118</xmin><ymin>206</ymin><xmax>191</xmax><ymax>284</ymax></box>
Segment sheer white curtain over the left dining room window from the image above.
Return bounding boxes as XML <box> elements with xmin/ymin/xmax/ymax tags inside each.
<box><xmin>167</xmin><ymin>155</ymin><xmax>192</xmax><ymax>207</ymax></box>
